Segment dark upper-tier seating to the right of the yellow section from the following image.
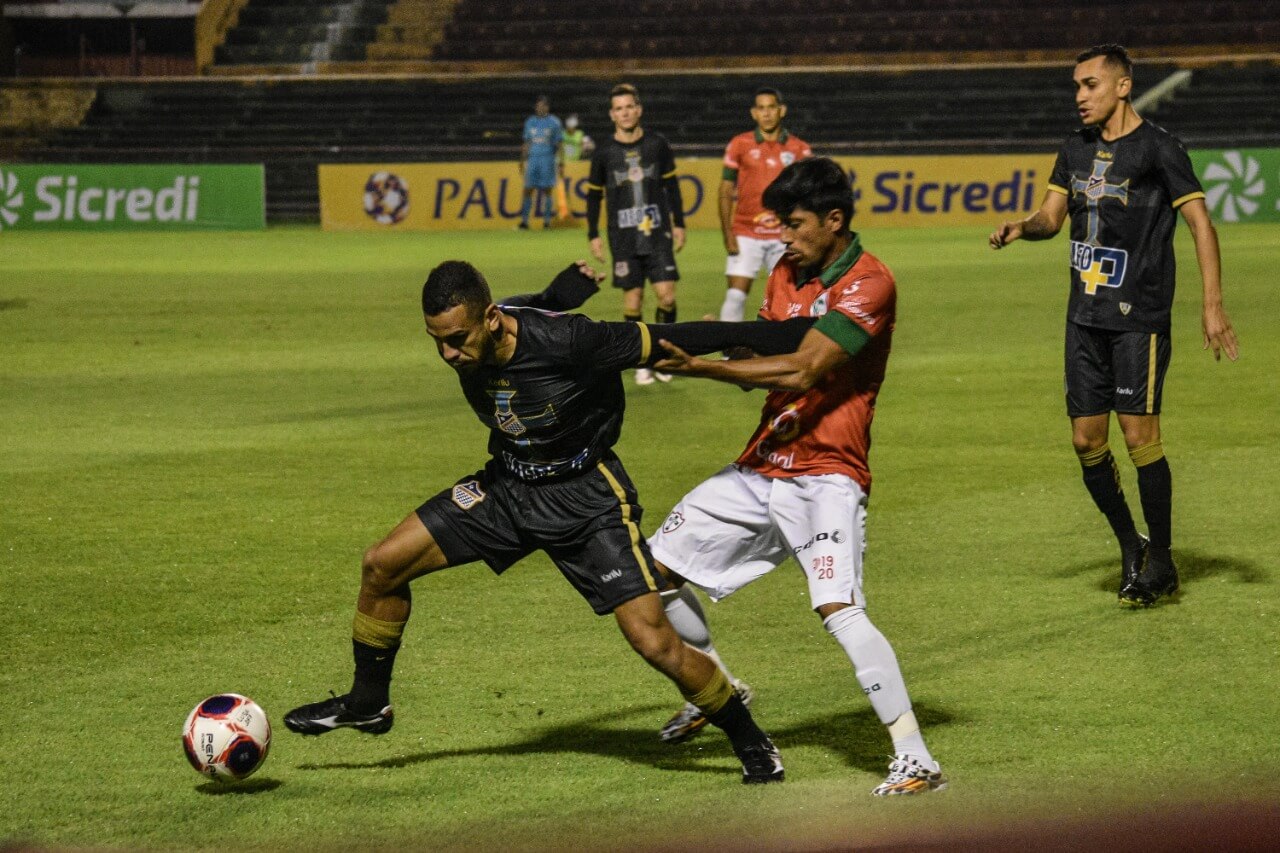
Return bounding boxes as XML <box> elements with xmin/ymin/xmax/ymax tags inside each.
<box><xmin>434</xmin><ymin>0</ymin><xmax>1280</xmax><ymax>60</ymax></box>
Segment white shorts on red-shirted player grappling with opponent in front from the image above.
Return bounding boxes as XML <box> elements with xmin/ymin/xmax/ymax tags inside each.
<box><xmin>649</xmin><ymin>465</ymin><xmax>867</xmax><ymax>610</ymax></box>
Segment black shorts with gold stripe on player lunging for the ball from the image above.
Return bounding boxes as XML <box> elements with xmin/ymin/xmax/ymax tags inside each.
<box><xmin>417</xmin><ymin>455</ymin><xmax>663</xmax><ymax>615</ymax></box>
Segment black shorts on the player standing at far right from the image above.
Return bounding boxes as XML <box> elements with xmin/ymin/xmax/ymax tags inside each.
<box><xmin>1065</xmin><ymin>323</ymin><xmax>1172</xmax><ymax>418</ymax></box>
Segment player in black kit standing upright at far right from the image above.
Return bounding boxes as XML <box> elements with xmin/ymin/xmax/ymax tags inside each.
<box><xmin>989</xmin><ymin>45</ymin><xmax>1238</xmax><ymax>607</ymax></box>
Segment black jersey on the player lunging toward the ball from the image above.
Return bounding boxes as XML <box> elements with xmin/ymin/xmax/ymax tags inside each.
<box><xmin>458</xmin><ymin>307</ymin><xmax>649</xmax><ymax>480</ymax></box>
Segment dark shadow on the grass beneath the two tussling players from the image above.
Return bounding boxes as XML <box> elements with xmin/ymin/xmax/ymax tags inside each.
<box><xmin>298</xmin><ymin>697</ymin><xmax>952</xmax><ymax>776</ymax></box>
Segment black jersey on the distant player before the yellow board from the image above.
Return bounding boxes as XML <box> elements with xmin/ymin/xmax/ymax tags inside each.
<box><xmin>588</xmin><ymin>131</ymin><xmax>684</xmax><ymax>257</ymax></box>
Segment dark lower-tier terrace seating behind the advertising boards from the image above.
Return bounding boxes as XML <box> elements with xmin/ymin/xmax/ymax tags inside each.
<box><xmin>17</xmin><ymin>65</ymin><xmax>1187</xmax><ymax>222</ymax></box>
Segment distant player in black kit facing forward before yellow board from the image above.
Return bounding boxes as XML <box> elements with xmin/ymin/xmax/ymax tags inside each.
<box><xmin>586</xmin><ymin>83</ymin><xmax>685</xmax><ymax>386</ymax></box>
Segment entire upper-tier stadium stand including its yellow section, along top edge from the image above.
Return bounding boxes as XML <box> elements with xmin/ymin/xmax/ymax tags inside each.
<box><xmin>189</xmin><ymin>0</ymin><xmax>1280</xmax><ymax>73</ymax></box>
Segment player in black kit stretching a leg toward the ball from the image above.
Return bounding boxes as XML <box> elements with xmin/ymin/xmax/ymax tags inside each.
<box><xmin>284</xmin><ymin>261</ymin><xmax>808</xmax><ymax>783</ymax></box>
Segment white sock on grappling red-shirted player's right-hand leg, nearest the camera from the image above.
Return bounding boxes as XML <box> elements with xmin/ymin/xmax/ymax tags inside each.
<box><xmin>822</xmin><ymin>607</ymin><xmax>937</xmax><ymax>768</ymax></box>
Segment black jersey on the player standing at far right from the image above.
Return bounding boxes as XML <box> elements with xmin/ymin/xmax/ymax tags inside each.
<box><xmin>1048</xmin><ymin>122</ymin><xmax>1204</xmax><ymax>333</ymax></box>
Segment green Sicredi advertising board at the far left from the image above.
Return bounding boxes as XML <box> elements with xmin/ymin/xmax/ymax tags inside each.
<box><xmin>0</xmin><ymin>164</ymin><xmax>266</xmax><ymax>232</ymax></box>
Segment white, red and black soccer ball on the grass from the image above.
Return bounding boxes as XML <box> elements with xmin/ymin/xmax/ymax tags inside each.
<box><xmin>182</xmin><ymin>693</ymin><xmax>271</xmax><ymax>781</ymax></box>
